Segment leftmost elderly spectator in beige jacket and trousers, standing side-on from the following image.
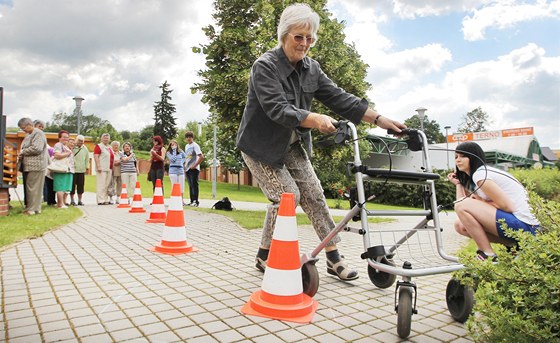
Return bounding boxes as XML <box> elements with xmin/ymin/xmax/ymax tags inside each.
<box><xmin>18</xmin><ymin>118</ymin><xmax>48</xmax><ymax>215</ymax></box>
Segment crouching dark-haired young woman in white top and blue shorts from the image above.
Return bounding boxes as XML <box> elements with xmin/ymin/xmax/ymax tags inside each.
<box><xmin>447</xmin><ymin>142</ymin><xmax>539</xmax><ymax>261</ymax></box>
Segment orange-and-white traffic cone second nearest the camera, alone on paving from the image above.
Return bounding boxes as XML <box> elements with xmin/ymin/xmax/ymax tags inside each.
<box><xmin>150</xmin><ymin>183</ymin><xmax>198</xmax><ymax>255</ymax></box>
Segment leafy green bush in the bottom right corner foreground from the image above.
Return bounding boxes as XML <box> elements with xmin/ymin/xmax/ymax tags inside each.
<box><xmin>456</xmin><ymin>192</ymin><xmax>560</xmax><ymax>342</ymax></box>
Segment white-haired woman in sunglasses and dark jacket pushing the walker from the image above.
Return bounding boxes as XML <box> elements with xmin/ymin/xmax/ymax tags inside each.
<box><xmin>237</xmin><ymin>4</ymin><xmax>406</xmax><ymax>280</ymax></box>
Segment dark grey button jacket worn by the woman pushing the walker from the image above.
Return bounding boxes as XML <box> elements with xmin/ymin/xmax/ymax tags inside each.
<box><xmin>236</xmin><ymin>47</ymin><xmax>368</xmax><ymax>168</ymax></box>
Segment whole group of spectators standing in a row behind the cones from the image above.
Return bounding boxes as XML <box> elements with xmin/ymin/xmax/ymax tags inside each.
<box><xmin>18</xmin><ymin>117</ymin><xmax>204</xmax><ymax>215</ymax></box>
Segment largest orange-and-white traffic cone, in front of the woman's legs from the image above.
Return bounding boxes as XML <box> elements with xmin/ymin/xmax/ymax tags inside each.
<box><xmin>241</xmin><ymin>193</ymin><xmax>319</xmax><ymax>323</ymax></box>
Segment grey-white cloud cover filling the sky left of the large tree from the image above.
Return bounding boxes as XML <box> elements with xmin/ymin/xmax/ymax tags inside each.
<box><xmin>0</xmin><ymin>0</ymin><xmax>212</xmax><ymax>130</ymax></box>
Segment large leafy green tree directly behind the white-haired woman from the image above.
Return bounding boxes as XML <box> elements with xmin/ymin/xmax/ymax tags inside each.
<box><xmin>191</xmin><ymin>0</ymin><xmax>376</xmax><ymax>196</ymax></box>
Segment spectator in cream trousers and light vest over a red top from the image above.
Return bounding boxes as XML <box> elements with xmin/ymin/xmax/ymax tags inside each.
<box><xmin>93</xmin><ymin>133</ymin><xmax>115</xmax><ymax>205</ymax></box>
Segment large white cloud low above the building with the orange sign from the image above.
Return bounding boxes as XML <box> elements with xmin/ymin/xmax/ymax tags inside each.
<box><xmin>370</xmin><ymin>43</ymin><xmax>560</xmax><ymax>147</ymax></box>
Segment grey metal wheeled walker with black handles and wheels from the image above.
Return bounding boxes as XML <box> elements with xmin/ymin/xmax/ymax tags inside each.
<box><xmin>301</xmin><ymin>121</ymin><xmax>474</xmax><ymax>338</ymax></box>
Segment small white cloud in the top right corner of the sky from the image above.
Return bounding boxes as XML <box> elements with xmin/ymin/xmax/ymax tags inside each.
<box><xmin>462</xmin><ymin>0</ymin><xmax>560</xmax><ymax>41</ymax></box>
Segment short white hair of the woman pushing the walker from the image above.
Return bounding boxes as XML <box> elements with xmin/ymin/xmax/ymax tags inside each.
<box><xmin>276</xmin><ymin>4</ymin><xmax>320</xmax><ymax>46</ymax></box>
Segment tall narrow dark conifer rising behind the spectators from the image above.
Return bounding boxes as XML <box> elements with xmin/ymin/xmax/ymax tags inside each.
<box><xmin>154</xmin><ymin>81</ymin><xmax>177</xmax><ymax>143</ymax></box>
